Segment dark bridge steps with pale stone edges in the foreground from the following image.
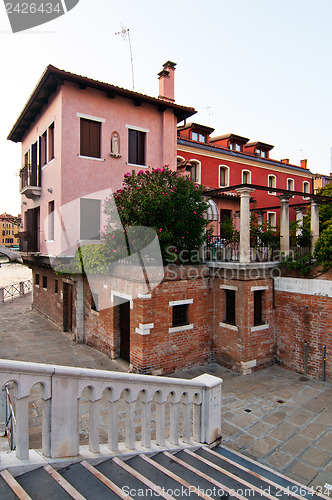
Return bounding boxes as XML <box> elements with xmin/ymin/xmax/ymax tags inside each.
<box><xmin>0</xmin><ymin>446</ymin><xmax>327</xmax><ymax>500</ymax></box>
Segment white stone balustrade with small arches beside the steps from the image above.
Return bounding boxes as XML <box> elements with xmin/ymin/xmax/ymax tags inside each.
<box><xmin>0</xmin><ymin>360</ymin><xmax>222</xmax><ymax>460</ymax></box>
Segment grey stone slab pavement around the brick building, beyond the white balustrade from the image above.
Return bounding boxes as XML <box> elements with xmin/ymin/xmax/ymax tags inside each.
<box><xmin>0</xmin><ymin>297</ymin><xmax>332</xmax><ymax>492</ymax></box>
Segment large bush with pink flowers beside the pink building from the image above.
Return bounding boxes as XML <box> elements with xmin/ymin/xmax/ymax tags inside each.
<box><xmin>102</xmin><ymin>166</ymin><xmax>208</xmax><ymax>263</ymax></box>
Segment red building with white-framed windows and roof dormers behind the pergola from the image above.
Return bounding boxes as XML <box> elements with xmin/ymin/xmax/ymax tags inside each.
<box><xmin>177</xmin><ymin>123</ymin><xmax>314</xmax><ymax>227</ymax></box>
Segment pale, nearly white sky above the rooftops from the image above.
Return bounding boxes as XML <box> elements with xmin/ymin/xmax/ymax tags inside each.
<box><xmin>0</xmin><ymin>0</ymin><xmax>332</xmax><ymax>215</ymax></box>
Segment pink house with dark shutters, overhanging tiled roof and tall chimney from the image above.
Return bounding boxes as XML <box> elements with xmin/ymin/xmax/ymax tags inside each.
<box><xmin>8</xmin><ymin>61</ymin><xmax>195</xmax><ymax>259</ymax></box>
